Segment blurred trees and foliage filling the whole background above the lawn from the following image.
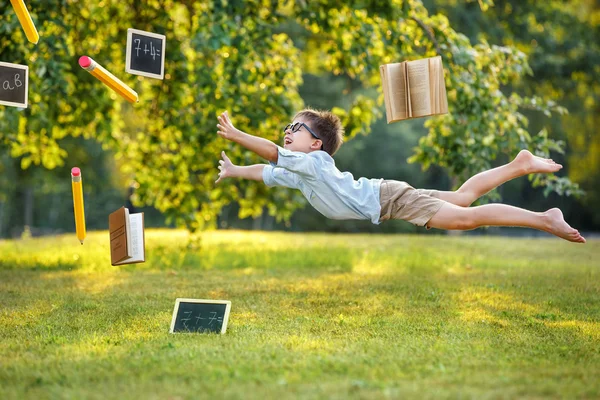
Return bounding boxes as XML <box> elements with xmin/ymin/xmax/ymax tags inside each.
<box><xmin>0</xmin><ymin>0</ymin><xmax>600</xmax><ymax>238</ymax></box>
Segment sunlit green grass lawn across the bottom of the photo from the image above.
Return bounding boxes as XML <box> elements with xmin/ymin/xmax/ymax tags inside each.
<box><xmin>0</xmin><ymin>230</ymin><xmax>600</xmax><ymax>399</ymax></box>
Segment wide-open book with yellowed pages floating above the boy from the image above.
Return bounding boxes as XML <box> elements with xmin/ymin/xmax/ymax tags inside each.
<box><xmin>379</xmin><ymin>56</ymin><xmax>448</xmax><ymax>124</ymax></box>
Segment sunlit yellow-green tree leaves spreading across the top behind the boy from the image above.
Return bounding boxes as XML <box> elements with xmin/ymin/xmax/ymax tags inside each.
<box><xmin>0</xmin><ymin>0</ymin><xmax>577</xmax><ymax>230</ymax></box>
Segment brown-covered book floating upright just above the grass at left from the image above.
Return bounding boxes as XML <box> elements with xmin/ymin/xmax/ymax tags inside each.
<box><xmin>108</xmin><ymin>207</ymin><xmax>146</xmax><ymax>265</ymax></box>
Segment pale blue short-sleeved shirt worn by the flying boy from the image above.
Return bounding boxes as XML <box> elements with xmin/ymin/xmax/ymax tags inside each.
<box><xmin>263</xmin><ymin>146</ymin><xmax>382</xmax><ymax>224</ymax></box>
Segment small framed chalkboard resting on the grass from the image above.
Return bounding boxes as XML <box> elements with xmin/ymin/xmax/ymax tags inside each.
<box><xmin>169</xmin><ymin>299</ymin><xmax>231</xmax><ymax>333</ymax></box>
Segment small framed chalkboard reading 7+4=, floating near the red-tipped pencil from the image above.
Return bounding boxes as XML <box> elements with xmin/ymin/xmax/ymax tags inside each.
<box><xmin>125</xmin><ymin>28</ymin><xmax>167</xmax><ymax>79</ymax></box>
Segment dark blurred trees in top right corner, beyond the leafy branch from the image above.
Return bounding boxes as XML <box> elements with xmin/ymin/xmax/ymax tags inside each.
<box><xmin>425</xmin><ymin>0</ymin><xmax>600</xmax><ymax>212</ymax></box>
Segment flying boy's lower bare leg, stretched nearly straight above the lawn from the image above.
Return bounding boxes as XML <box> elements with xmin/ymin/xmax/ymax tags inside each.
<box><xmin>427</xmin><ymin>203</ymin><xmax>585</xmax><ymax>243</ymax></box>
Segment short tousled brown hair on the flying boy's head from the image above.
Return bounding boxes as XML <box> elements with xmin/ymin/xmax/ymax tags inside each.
<box><xmin>294</xmin><ymin>107</ymin><xmax>344</xmax><ymax>156</ymax></box>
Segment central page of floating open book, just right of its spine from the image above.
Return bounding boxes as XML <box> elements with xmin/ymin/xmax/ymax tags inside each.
<box><xmin>406</xmin><ymin>58</ymin><xmax>432</xmax><ymax>117</ymax></box>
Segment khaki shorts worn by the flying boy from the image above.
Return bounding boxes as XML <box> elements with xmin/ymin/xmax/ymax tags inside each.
<box><xmin>379</xmin><ymin>179</ymin><xmax>446</xmax><ymax>228</ymax></box>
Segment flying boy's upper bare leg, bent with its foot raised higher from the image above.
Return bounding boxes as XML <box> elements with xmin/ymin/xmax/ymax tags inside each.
<box><xmin>436</xmin><ymin>150</ymin><xmax>562</xmax><ymax>207</ymax></box>
